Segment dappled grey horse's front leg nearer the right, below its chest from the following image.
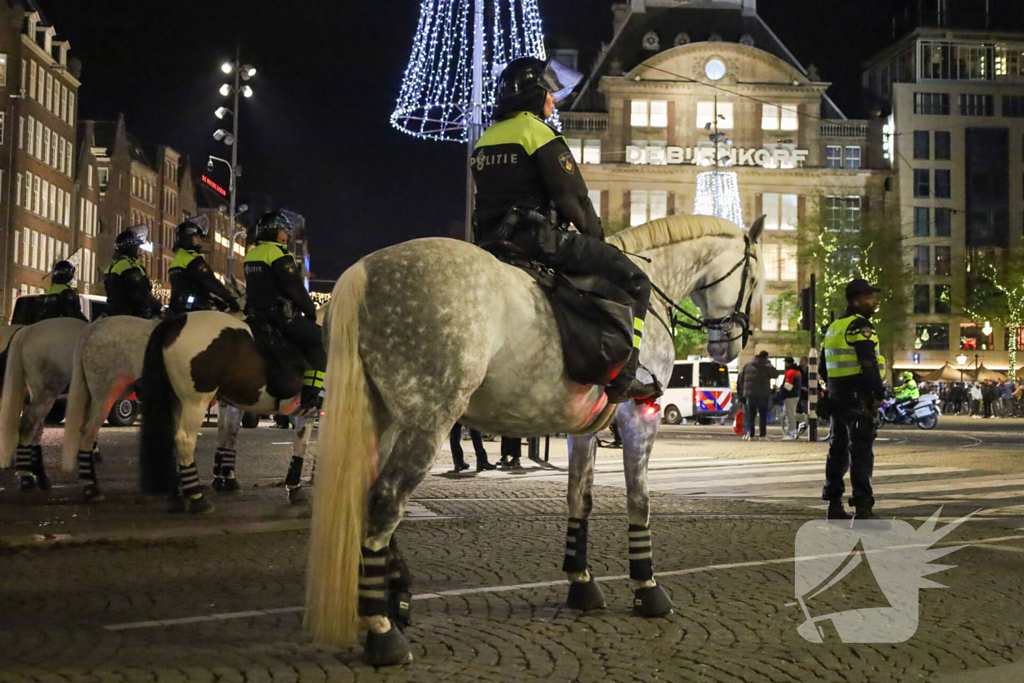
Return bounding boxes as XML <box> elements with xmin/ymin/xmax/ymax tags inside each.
<box><xmin>615</xmin><ymin>401</ymin><xmax>673</xmax><ymax>616</ymax></box>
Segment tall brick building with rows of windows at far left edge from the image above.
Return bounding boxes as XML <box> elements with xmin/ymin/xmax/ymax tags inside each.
<box><xmin>0</xmin><ymin>0</ymin><xmax>81</xmax><ymax>317</ymax></box>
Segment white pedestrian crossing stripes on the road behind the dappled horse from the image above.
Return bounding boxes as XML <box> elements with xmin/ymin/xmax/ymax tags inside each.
<box><xmin>437</xmin><ymin>451</ymin><xmax>1024</xmax><ymax>516</ymax></box>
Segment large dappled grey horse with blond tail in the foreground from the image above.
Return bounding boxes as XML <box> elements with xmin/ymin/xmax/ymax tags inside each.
<box><xmin>306</xmin><ymin>216</ymin><xmax>764</xmax><ymax>666</ymax></box>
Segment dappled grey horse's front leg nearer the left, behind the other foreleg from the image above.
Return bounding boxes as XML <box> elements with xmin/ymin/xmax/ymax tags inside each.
<box><xmin>562</xmin><ymin>434</ymin><xmax>605</xmax><ymax>611</ymax></box>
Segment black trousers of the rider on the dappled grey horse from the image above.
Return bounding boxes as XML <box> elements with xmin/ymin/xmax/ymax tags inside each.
<box><xmin>512</xmin><ymin>230</ymin><xmax>650</xmax><ymax>318</ymax></box>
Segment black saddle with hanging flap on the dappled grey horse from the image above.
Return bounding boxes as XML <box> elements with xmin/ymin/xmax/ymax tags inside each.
<box><xmin>480</xmin><ymin>240</ymin><xmax>633</xmax><ymax>386</ymax></box>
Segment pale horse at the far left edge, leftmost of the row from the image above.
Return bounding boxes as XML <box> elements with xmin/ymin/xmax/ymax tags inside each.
<box><xmin>0</xmin><ymin>317</ymin><xmax>88</xmax><ymax>490</ymax></box>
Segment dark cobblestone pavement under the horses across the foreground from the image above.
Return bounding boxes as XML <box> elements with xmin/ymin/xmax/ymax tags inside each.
<box><xmin>0</xmin><ymin>421</ymin><xmax>1024</xmax><ymax>682</ymax></box>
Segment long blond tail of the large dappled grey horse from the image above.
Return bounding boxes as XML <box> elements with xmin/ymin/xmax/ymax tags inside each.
<box><xmin>306</xmin><ymin>261</ymin><xmax>378</xmax><ymax>645</ymax></box>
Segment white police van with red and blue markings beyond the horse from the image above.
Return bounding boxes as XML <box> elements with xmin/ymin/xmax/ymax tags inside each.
<box><xmin>660</xmin><ymin>360</ymin><xmax>732</xmax><ymax>425</ymax></box>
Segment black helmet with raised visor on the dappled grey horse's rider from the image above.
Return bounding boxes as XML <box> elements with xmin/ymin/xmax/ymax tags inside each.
<box><xmin>495</xmin><ymin>57</ymin><xmax>583</xmax><ymax>119</ymax></box>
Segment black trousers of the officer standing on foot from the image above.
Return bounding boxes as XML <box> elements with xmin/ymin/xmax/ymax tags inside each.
<box><xmin>821</xmin><ymin>396</ymin><xmax>877</xmax><ymax>507</ymax></box>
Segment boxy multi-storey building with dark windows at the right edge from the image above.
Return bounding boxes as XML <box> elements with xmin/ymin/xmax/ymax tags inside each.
<box><xmin>863</xmin><ymin>0</ymin><xmax>1024</xmax><ymax>370</ymax></box>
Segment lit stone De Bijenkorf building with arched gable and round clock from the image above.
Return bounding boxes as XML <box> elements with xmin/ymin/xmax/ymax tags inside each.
<box><xmin>556</xmin><ymin>0</ymin><xmax>890</xmax><ymax>354</ymax></box>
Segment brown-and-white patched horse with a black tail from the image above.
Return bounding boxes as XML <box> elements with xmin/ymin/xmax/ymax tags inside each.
<box><xmin>139</xmin><ymin>306</ymin><xmax>329</xmax><ymax>513</ymax></box>
